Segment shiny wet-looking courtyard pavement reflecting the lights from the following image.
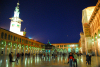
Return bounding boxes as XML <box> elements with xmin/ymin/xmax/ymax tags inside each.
<box><xmin>0</xmin><ymin>55</ymin><xmax>100</xmax><ymax>67</ymax></box>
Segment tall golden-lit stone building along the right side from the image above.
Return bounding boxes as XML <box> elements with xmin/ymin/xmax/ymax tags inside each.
<box><xmin>80</xmin><ymin>0</ymin><xmax>100</xmax><ymax>56</ymax></box>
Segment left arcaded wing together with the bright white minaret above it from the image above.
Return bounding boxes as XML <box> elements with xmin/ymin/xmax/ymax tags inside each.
<box><xmin>0</xmin><ymin>3</ymin><xmax>44</xmax><ymax>55</ymax></box>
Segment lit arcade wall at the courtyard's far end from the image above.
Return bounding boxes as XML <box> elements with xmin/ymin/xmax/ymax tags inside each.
<box><xmin>51</xmin><ymin>43</ymin><xmax>81</xmax><ymax>53</ymax></box>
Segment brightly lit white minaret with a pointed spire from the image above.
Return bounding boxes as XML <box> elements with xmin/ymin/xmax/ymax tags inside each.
<box><xmin>10</xmin><ymin>2</ymin><xmax>23</xmax><ymax>34</ymax></box>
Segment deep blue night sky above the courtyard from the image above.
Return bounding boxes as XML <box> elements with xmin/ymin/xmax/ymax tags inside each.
<box><xmin>0</xmin><ymin>0</ymin><xmax>98</xmax><ymax>43</ymax></box>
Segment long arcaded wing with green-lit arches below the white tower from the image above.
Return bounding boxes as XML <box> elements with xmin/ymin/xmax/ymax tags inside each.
<box><xmin>0</xmin><ymin>28</ymin><xmax>44</xmax><ymax>55</ymax></box>
